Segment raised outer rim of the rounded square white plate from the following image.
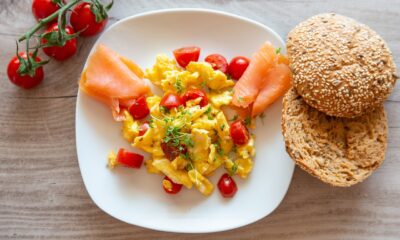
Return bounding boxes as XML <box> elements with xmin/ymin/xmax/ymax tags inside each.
<box><xmin>75</xmin><ymin>8</ymin><xmax>295</xmax><ymax>233</ymax></box>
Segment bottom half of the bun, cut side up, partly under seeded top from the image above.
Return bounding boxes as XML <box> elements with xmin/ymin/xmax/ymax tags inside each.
<box><xmin>282</xmin><ymin>88</ymin><xmax>388</xmax><ymax>187</ymax></box>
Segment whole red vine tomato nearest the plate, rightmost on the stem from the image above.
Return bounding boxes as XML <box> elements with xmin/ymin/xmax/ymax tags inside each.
<box><xmin>70</xmin><ymin>2</ymin><xmax>108</xmax><ymax>37</ymax></box>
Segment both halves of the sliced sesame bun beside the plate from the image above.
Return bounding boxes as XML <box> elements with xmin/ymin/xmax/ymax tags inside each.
<box><xmin>282</xmin><ymin>13</ymin><xmax>397</xmax><ymax>187</ymax></box>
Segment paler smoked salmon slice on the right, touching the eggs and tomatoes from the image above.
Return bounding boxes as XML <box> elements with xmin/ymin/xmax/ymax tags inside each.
<box><xmin>232</xmin><ymin>42</ymin><xmax>276</xmax><ymax>108</ymax></box>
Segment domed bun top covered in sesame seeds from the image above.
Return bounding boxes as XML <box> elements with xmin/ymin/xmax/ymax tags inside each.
<box><xmin>287</xmin><ymin>13</ymin><xmax>397</xmax><ymax>118</ymax></box>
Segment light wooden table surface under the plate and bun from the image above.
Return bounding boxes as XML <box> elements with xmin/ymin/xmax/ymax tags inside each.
<box><xmin>0</xmin><ymin>0</ymin><xmax>400</xmax><ymax>240</ymax></box>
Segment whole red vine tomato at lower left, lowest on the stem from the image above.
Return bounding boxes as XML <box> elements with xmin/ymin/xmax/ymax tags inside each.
<box><xmin>7</xmin><ymin>53</ymin><xmax>44</xmax><ymax>89</ymax></box>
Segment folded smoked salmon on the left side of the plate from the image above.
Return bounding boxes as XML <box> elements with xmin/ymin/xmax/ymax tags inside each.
<box><xmin>79</xmin><ymin>44</ymin><xmax>150</xmax><ymax>121</ymax></box>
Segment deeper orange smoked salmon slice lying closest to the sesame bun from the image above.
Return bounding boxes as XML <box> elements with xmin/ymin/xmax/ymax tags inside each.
<box><xmin>251</xmin><ymin>64</ymin><xmax>292</xmax><ymax>117</ymax></box>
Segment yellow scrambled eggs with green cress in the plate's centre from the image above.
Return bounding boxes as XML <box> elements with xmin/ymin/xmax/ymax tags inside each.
<box><xmin>122</xmin><ymin>55</ymin><xmax>255</xmax><ymax>196</ymax></box>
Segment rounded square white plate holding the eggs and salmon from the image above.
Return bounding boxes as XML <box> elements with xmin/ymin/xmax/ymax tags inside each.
<box><xmin>76</xmin><ymin>9</ymin><xmax>294</xmax><ymax>233</ymax></box>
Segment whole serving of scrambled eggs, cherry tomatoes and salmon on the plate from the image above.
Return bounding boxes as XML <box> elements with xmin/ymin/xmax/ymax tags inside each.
<box><xmin>80</xmin><ymin>42</ymin><xmax>292</xmax><ymax>198</ymax></box>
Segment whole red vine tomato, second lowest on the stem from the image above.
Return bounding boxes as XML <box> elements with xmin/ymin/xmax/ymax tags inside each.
<box><xmin>42</xmin><ymin>23</ymin><xmax>77</xmax><ymax>61</ymax></box>
